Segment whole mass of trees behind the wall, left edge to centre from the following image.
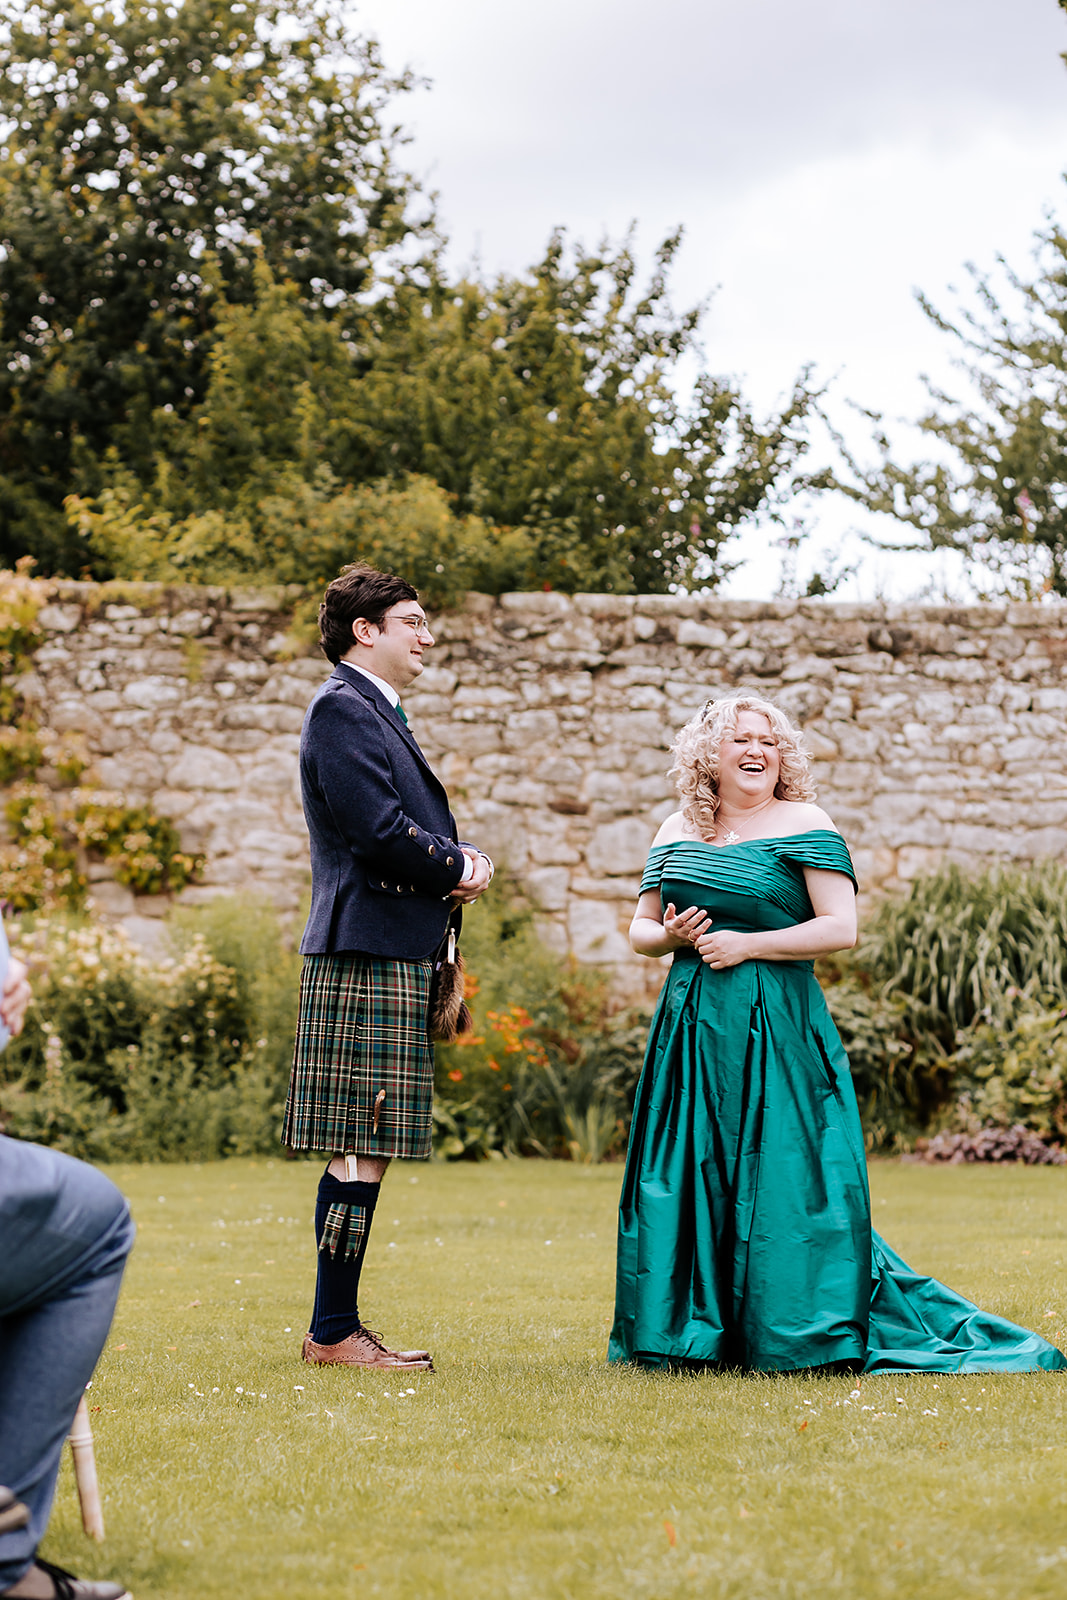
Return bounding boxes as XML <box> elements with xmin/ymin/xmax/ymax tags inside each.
<box><xmin>0</xmin><ymin>0</ymin><xmax>814</xmax><ymax>605</ymax></box>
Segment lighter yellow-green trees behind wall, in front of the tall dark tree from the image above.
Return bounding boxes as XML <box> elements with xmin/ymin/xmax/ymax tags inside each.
<box><xmin>69</xmin><ymin>240</ymin><xmax>813</xmax><ymax>598</ymax></box>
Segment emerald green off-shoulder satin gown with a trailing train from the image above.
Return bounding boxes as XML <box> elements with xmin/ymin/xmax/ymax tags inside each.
<box><xmin>608</xmin><ymin>829</ymin><xmax>1067</xmax><ymax>1373</ymax></box>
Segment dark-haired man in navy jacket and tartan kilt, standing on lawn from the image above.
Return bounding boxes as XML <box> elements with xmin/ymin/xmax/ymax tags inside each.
<box><xmin>282</xmin><ymin>563</ymin><xmax>493</xmax><ymax>1371</ymax></box>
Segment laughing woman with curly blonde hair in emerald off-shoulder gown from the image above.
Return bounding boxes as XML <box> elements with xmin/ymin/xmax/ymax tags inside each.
<box><xmin>608</xmin><ymin>696</ymin><xmax>1067</xmax><ymax>1373</ymax></box>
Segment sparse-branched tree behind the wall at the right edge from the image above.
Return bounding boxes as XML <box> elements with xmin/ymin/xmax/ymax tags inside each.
<box><xmin>835</xmin><ymin>224</ymin><xmax>1067</xmax><ymax>598</ymax></box>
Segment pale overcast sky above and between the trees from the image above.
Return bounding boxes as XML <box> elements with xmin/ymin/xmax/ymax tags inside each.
<box><xmin>354</xmin><ymin>0</ymin><xmax>1067</xmax><ymax>598</ymax></box>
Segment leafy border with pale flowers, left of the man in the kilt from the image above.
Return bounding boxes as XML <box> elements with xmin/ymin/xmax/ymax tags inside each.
<box><xmin>0</xmin><ymin>904</ymin><xmax>299</xmax><ymax>1160</ymax></box>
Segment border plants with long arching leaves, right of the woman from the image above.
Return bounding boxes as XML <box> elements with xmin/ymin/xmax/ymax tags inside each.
<box><xmin>821</xmin><ymin>862</ymin><xmax>1067</xmax><ymax>1147</ymax></box>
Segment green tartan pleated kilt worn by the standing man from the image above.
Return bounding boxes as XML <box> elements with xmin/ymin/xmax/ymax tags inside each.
<box><xmin>282</xmin><ymin>950</ymin><xmax>434</xmax><ymax>1160</ymax></box>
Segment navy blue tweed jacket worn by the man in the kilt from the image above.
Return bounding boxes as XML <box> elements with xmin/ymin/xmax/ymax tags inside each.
<box><xmin>301</xmin><ymin>662</ymin><xmax>464</xmax><ymax>962</ymax></box>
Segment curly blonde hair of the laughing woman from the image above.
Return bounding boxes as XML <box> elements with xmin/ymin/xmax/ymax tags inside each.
<box><xmin>669</xmin><ymin>694</ymin><xmax>816</xmax><ymax>838</ymax></box>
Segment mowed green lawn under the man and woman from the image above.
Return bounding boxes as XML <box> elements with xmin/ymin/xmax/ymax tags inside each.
<box><xmin>45</xmin><ymin>1160</ymin><xmax>1067</xmax><ymax>1600</ymax></box>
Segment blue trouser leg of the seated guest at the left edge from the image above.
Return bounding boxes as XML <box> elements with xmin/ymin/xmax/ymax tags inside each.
<box><xmin>0</xmin><ymin>1136</ymin><xmax>133</xmax><ymax>1590</ymax></box>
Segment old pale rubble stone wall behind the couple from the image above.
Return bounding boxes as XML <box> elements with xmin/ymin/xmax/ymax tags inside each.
<box><xmin>12</xmin><ymin>582</ymin><xmax>1067</xmax><ymax>990</ymax></box>
